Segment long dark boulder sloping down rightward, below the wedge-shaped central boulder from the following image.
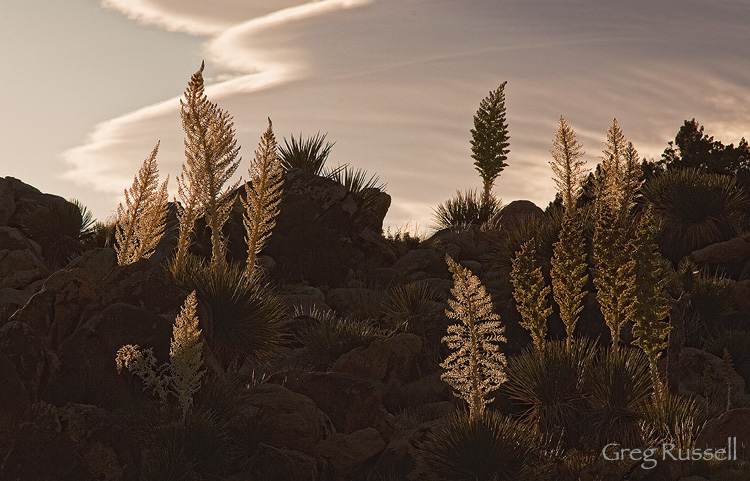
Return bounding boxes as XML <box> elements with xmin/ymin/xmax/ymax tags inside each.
<box><xmin>270</xmin><ymin>371</ymin><xmax>394</xmax><ymax>439</ymax></box>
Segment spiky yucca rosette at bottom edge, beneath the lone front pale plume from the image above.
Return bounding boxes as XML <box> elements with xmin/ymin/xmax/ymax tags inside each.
<box><xmin>419</xmin><ymin>410</ymin><xmax>543</xmax><ymax>481</ymax></box>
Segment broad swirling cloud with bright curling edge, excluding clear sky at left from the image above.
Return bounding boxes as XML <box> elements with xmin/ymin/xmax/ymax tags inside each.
<box><xmin>65</xmin><ymin>0</ymin><xmax>750</xmax><ymax>225</ymax></box>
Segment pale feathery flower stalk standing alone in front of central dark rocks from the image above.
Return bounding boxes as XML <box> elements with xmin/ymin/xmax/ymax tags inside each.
<box><xmin>440</xmin><ymin>255</ymin><xmax>507</xmax><ymax>417</ymax></box>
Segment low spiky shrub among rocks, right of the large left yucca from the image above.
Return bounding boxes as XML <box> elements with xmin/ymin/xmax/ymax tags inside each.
<box><xmin>299</xmin><ymin>314</ymin><xmax>384</xmax><ymax>371</ymax></box>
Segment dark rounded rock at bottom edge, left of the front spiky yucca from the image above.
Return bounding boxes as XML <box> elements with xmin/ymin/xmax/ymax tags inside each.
<box><xmin>319</xmin><ymin>428</ymin><xmax>386</xmax><ymax>481</ymax></box>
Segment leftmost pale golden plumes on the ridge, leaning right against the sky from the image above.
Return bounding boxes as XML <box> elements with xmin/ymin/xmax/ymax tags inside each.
<box><xmin>115</xmin><ymin>143</ymin><xmax>169</xmax><ymax>266</ymax></box>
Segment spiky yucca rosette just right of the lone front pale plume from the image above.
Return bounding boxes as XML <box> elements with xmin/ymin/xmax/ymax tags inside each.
<box><xmin>504</xmin><ymin>339</ymin><xmax>596</xmax><ymax>447</ymax></box>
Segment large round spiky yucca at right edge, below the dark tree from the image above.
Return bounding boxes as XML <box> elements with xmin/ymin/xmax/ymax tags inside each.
<box><xmin>642</xmin><ymin>168</ymin><xmax>748</xmax><ymax>264</ymax></box>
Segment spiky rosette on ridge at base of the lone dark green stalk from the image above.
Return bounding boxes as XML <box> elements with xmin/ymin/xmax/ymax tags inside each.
<box><xmin>432</xmin><ymin>190</ymin><xmax>502</xmax><ymax>230</ymax></box>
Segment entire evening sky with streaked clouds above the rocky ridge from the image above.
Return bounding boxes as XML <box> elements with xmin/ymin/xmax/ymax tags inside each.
<box><xmin>0</xmin><ymin>0</ymin><xmax>750</xmax><ymax>230</ymax></box>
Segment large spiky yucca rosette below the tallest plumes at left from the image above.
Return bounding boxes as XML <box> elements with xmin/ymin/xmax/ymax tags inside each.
<box><xmin>178</xmin><ymin>262</ymin><xmax>286</xmax><ymax>367</ymax></box>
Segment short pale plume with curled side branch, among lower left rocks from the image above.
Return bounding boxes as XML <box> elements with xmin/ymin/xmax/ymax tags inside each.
<box><xmin>115</xmin><ymin>292</ymin><xmax>204</xmax><ymax>419</ymax></box>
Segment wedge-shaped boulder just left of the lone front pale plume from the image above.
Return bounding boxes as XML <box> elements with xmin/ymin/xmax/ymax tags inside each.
<box><xmin>330</xmin><ymin>333</ymin><xmax>422</xmax><ymax>382</ymax></box>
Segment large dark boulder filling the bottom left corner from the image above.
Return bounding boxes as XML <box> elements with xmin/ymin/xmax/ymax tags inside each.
<box><xmin>0</xmin><ymin>404</ymin><xmax>141</xmax><ymax>481</ymax></box>
